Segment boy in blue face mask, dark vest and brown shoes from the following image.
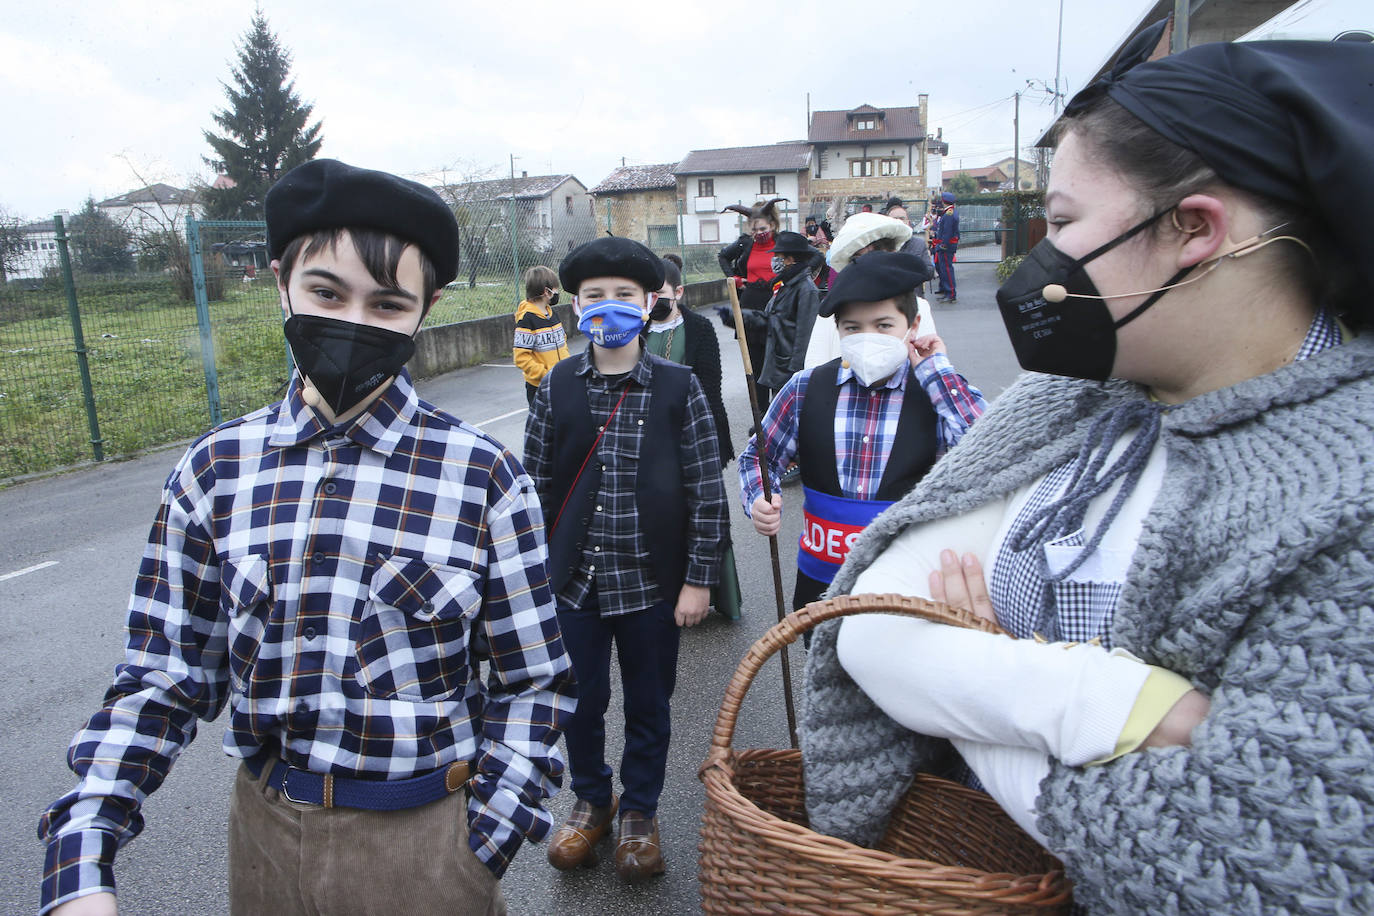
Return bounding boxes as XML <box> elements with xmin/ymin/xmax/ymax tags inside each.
<box><xmin>525</xmin><ymin>238</ymin><xmax>727</xmax><ymax>882</ymax></box>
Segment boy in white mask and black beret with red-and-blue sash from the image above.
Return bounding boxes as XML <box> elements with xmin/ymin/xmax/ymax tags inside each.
<box><xmin>739</xmin><ymin>251</ymin><xmax>987</xmax><ymax>610</ymax></box>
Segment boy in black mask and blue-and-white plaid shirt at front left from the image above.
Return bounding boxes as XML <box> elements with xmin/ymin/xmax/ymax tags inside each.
<box><xmin>40</xmin><ymin>159</ymin><xmax>574</xmax><ymax>916</ymax></box>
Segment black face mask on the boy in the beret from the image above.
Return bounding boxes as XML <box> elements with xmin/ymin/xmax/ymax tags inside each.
<box><xmin>284</xmin><ymin>313</ymin><xmax>415</xmax><ymax>416</ymax></box>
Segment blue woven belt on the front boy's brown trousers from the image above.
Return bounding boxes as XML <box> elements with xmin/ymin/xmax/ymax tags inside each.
<box><xmin>243</xmin><ymin>754</ymin><xmax>470</xmax><ymax>812</ymax></box>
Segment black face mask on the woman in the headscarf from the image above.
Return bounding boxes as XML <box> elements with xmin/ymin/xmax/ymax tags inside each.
<box><xmin>998</xmin><ymin>210</ymin><xmax>1193</xmax><ymax>382</ymax></box>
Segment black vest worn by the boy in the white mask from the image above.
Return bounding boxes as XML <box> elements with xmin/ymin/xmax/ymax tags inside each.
<box><xmin>797</xmin><ymin>358</ymin><xmax>940</xmax><ymax>503</ymax></box>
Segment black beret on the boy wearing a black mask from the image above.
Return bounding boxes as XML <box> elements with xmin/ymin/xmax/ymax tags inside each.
<box><xmin>265</xmin><ymin>159</ymin><xmax>458</xmax><ymax>286</ymax></box>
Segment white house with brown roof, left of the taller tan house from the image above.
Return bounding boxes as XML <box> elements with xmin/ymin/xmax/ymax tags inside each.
<box><xmin>673</xmin><ymin>140</ymin><xmax>811</xmax><ymax>244</ymax></box>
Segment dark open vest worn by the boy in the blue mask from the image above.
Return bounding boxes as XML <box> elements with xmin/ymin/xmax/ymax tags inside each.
<box><xmin>544</xmin><ymin>356</ymin><xmax>691</xmax><ymax>602</ymax></box>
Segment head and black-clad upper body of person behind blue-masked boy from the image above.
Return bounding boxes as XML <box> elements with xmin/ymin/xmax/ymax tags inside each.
<box><xmin>647</xmin><ymin>254</ymin><xmax>735</xmax><ymax>467</ymax></box>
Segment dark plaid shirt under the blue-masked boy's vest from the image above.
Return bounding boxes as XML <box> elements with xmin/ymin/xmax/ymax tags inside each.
<box><xmin>525</xmin><ymin>347</ymin><xmax>727</xmax><ymax>617</ymax></box>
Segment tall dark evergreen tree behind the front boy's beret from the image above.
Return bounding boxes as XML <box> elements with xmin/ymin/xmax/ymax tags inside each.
<box><xmin>205</xmin><ymin>10</ymin><xmax>324</xmax><ymax>220</ymax></box>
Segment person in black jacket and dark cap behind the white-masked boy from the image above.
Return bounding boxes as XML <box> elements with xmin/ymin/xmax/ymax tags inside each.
<box><xmin>757</xmin><ymin>232</ymin><xmax>820</xmax><ymax>391</ymax></box>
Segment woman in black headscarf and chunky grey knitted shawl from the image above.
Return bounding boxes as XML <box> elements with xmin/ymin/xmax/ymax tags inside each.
<box><xmin>801</xmin><ymin>32</ymin><xmax>1374</xmax><ymax>913</ymax></box>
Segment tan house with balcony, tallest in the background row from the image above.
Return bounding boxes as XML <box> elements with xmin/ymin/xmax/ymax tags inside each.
<box><xmin>804</xmin><ymin>93</ymin><xmax>949</xmax><ymax>217</ymax></box>
